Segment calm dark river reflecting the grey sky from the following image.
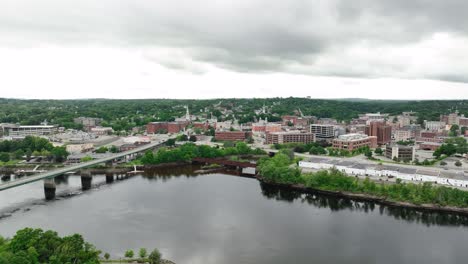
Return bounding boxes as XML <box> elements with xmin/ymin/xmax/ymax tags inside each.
<box><xmin>0</xmin><ymin>168</ymin><xmax>468</xmax><ymax>264</ymax></box>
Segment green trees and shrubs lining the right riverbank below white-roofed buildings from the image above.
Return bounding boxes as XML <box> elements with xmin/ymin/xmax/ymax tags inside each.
<box><xmin>258</xmin><ymin>153</ymin><xmax>468</xmax><ymax>207</ymax></box>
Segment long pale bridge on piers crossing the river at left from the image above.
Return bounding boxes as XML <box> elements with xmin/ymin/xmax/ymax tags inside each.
<box><xmin>0</xmin><ymin>141</ymin><xmax>165</xmax><ymax>199</ymax></box>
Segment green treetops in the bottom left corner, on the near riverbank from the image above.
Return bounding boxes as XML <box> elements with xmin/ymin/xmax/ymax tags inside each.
<box><xmin>0</xmin><ymin>228</ymin><xmax>100</xmax><ymax>264</ymax></box>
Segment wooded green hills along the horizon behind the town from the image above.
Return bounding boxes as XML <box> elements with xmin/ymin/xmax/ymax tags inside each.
<box><xmin>0</xmin><ymin>97</ymin><xmax>468</xmax><ymax>131</ymax></box>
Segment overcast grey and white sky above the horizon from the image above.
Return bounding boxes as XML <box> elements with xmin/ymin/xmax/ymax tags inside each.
<box><xmin>0</xmin><ymin>0</ymin><xmax>468</xmax><ymax>99</ymax></box>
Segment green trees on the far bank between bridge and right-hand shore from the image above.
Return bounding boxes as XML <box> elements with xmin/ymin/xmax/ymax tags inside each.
<box><xmin>141</xmin><ymin>142</ymin><xmax>265</xmax><ymax>164</ymax></box>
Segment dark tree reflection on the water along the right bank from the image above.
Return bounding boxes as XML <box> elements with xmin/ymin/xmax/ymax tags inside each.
<box><xmin>260</xmin><ymin>182</ymin><xmax>468</xmax><ymax>226</ymax></box>
